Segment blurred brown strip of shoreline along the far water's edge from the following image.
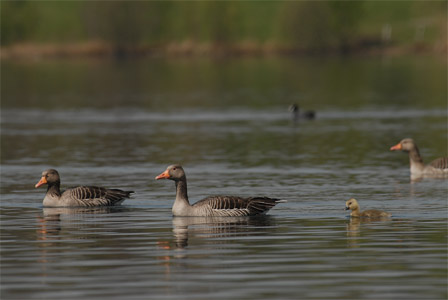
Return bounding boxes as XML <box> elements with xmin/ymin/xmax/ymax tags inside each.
<box><xmin>0</xmin><ymin>41</ymin><xmax>447</xmax><ymax>60</ymax></box>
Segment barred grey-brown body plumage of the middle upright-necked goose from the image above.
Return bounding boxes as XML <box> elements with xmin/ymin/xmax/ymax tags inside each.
<box><xmin>193</xmin><ymin>196</ymin><xmax>284</xmax><ymax>217</ymax></box>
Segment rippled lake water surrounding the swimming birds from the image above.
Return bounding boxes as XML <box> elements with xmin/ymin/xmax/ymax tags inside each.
<box><xmin>1</xmin><ymin>57</ymin><xmax>448</xmax><ymax>300</ymax></box>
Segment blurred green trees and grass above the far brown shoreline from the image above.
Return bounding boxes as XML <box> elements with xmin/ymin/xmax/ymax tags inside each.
<box><xmin>0</xmin><ymin>0</ymin><xmax>447</xmax><ymax>54</ymax></box>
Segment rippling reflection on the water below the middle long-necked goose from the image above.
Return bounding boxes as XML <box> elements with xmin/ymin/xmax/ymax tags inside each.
<box><xmin>173</xmin><ymin>216</ymin><xmax>273</xmax><ymax>249</ymax></box>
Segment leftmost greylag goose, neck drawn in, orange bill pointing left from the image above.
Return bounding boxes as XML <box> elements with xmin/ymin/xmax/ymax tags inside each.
<box><xmin>35</xmin><ymin>169</ymin><xmax>133</xmax><ymax>207</ymax></box>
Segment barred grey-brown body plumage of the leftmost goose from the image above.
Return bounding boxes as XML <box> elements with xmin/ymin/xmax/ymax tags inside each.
<box><xmin>60</xmin><ymin>186</ymin><xmax>133</xmax><ymax>207</ymax></box>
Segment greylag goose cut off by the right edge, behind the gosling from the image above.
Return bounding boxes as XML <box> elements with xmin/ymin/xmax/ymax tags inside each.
<box><xmin>390</xmin><ymin>138</ymin><xmax>448</xmax><ymax>176</ymax></box>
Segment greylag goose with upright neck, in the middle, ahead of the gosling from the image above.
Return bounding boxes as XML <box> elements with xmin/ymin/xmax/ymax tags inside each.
<box><xmin>156</xmin><ymin>165</ymin><xmax>286</xmax><ymax>217</ymax></box>
